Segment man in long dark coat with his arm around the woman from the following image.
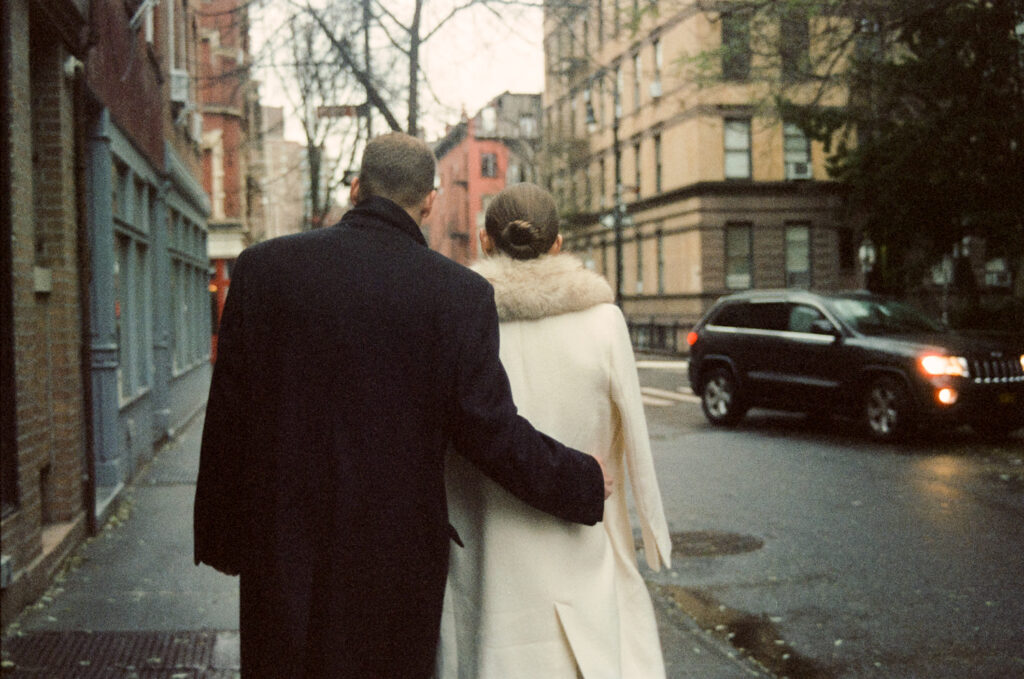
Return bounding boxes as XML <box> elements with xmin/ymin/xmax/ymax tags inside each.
<box><xmin>195</xmin><ymin>133</ymin><xmax>610</xmax><ymax>679</ymax></box>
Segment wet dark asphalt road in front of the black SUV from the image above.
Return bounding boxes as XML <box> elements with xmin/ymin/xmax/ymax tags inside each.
<box><xmin>640</xmin><ymin>364</ymin><xmax>1024</xmax><ymax>679</ymax></box>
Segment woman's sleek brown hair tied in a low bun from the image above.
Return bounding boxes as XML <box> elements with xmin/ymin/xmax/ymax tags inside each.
<box><xmin>484</xmin><ymin>183</ymin><xmax>558</xmax><ymax>259</ymax></box>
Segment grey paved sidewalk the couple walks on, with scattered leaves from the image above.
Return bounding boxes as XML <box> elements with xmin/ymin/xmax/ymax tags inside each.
<box><xmin>3</xmin><ymin>405</ymin><xmax>767</xmax><ymax>679</ymax></box>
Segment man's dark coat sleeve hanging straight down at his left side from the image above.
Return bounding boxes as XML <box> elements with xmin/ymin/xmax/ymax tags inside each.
<box><xmin>193</xmin><ymin>253</ymin><xmax>254</xmax><ymax>575</ymax></box>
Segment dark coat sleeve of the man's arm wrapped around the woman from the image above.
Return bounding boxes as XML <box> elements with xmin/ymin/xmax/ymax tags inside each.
<box><xmin>452</xmin><ymin>285</ymin><xmax>604</xmax><ymax>525</ymax></box>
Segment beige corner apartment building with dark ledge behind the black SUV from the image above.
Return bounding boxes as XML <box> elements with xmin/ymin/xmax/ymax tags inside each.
<box><xmin>542</xmin><ymin>5</ymin><xmax>861</xmax><ymax>350</ymax></box>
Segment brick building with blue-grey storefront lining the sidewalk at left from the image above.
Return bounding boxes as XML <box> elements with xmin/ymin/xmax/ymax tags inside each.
<box><xmin>0</xmin><ymin>0</ymin><xmax>209</xmax><ymax>624</ymax></box>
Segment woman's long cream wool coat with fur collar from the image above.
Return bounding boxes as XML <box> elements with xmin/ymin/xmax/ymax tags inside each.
<box><xmin>437</xmin><ymin>254</ymin><xmax>672</xmax><ymax>679</ymax></box>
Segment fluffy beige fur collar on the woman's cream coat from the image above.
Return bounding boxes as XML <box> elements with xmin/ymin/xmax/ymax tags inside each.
<box><xmin>473</xmin><ymin>253</ymin><xmax>614</xmax><ymax>321</ymax></box>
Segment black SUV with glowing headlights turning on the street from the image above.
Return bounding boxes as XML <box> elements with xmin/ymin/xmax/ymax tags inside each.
<box><xmin>687</xmin><ymin>290</ymin><xmax>1024</xmax><ymax>439</ymax></box>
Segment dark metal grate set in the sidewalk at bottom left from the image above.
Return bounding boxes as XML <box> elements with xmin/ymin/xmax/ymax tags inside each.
<box><xmin>3</xmin><ymin>631</ymin><xmax>239</xmax><ymax>679</ymax></box>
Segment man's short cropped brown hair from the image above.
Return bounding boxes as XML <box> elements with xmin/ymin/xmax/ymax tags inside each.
<box><xmin>358</xmin><ymin>132</ymin><xmax>437</xmax><ymax>208</ymax></box>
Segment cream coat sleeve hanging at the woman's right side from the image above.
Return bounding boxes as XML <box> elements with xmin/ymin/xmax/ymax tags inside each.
<box><xmin>611</xmin><ymin>309</ymin><xmax>672</xmax><ymax>570</ymax></box>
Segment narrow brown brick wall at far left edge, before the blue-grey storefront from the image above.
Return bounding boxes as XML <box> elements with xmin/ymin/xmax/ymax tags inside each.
<box><xmin>2</xmin><ymin>2</ymin><xmax>85</xmax><ymax>609</ymax></box>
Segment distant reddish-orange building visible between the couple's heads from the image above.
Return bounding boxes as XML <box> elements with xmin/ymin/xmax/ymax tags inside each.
<box><xmin>423</xmin><ymin>92</ymin><xmax>541</xmax><ymax>264</ymax></box>
